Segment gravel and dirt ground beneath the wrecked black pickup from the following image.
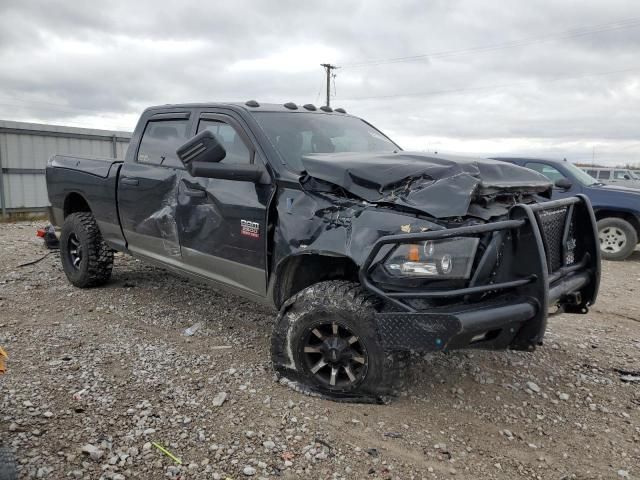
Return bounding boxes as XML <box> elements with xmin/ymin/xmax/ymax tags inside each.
<box><xmin>0</xmin><ymin>223</ymin><xmax>640</xmax><ymax>480</ymax></box>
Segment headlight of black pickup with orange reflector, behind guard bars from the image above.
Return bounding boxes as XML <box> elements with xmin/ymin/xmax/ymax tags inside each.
<box><xmin>384</xmin><ymin>237</ymin><xmax>478</xmax><ymax>279</ymax></box>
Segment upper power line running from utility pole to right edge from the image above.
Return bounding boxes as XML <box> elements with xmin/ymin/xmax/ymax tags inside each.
<box><xmin>342</xmin><ymin>17</ymin><xmax>640</xmax><ymax>68</ymax></box>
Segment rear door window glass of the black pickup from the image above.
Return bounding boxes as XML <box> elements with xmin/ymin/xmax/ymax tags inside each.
<box><xmin>138</xmin><ymin>119</ymin><xmax>189</xmax><ymax>167</ymax></box>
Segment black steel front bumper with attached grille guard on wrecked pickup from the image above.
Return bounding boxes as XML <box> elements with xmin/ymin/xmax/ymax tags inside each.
<box><xmin>360</xmin><ymin>195</ymin><xmax>600</xmax><ymax>352</ymax></box>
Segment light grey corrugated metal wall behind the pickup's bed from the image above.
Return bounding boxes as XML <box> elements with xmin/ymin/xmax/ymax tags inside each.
<box><xmin>0</xmin><ymin>120</ymin><xmax>131</xmax><ymax>215</ymax></box>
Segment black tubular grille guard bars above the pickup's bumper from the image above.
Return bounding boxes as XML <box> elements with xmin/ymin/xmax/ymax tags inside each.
<box><xmin>359</xmin><ymin>195</ymin><xmax>600</xmax><ymax>316</ymax></box>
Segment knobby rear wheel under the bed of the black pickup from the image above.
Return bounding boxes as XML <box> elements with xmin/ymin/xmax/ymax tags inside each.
<box><xmin>60</xmin><ymin>212</ymin><xmax>113</xmax><ymax>288</ymax></box>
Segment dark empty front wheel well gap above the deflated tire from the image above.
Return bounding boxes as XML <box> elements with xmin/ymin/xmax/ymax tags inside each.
<box><xmin>274</xmin><ymin>254</ymin><xmax>358</xmax><ymax>308</ymax></box>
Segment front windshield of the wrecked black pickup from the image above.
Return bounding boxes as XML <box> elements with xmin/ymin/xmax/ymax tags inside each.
<box><xmin>253</xmin><ymin>112</ymin><xmax>401</xmax><ymax>172</ymax></box>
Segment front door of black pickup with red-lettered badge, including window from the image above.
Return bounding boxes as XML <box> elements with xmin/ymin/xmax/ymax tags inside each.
<box><xmin>177</xmin><ymin>113</ymin><xmax>273</xmax><ymax>296</ymax></box>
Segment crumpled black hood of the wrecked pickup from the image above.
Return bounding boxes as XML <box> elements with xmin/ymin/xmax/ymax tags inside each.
<box><xmin>302</xmin><ymin>152</ymin><xmax>552</xmax><ymax>218</ymax></box>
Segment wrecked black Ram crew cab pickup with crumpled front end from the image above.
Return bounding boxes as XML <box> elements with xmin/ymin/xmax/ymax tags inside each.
<box><xmin>47</xmin><ymin>101</ymin><xmax>600</xmax><ymax>400</ymax></box>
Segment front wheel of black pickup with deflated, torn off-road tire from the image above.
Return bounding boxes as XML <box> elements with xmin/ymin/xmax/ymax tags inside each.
<box><xmin>271</xmin><ymin>280</ymin><xmax>406</xmax><ymax>403</ymax></box>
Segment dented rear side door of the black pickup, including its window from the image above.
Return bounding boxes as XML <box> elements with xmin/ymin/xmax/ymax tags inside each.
<box><xmin>118</xmin><ymin>113</ymin><xmax>191</xmax><ymax>264</ymax></box>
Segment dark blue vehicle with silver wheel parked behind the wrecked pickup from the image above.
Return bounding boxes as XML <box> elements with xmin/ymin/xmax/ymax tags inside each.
<box><xmin>500</xmin><ymin>158</ymin><xmax>640</xmax><ymax>260</ymax></box>
